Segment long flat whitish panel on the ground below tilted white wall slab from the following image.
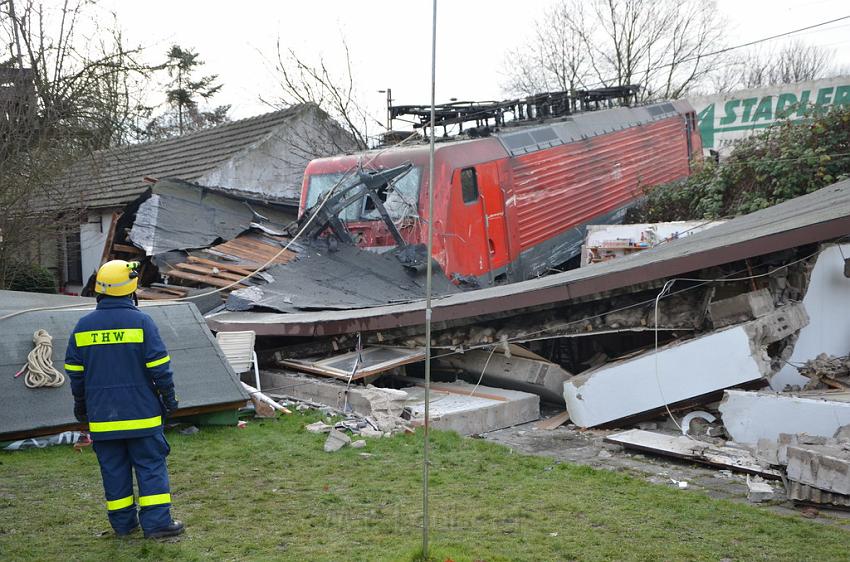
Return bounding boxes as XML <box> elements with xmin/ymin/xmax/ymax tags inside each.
<box><xmin>605</xmin><ymin>429</ymin><xmax>782</xmax><ymax>480</ymax></box>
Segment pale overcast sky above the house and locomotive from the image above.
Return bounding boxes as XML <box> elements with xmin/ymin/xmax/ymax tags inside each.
<box><xmin>103</xmin><ymin>0</ymin><xmax>850</xmax><ymax>126</ymax></box>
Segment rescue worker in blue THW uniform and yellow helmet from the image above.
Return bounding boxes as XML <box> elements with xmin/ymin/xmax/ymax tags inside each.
<box><xmin>65</xmin><ymin>260</ymin><xmax>183</xmax><ymax>538</ymax></box>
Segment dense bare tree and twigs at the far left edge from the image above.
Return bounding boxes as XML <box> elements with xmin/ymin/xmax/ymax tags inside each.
<box><xmin>0</xmin><ymin>0</ymin><xmax>151</xmax><ymax>286</ymax></box>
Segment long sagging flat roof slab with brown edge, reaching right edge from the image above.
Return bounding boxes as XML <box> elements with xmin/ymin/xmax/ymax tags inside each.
<box><xmin>207</xmin><ymin>176</ymin><xmax>850</xmax><ymax>335</ymax></box>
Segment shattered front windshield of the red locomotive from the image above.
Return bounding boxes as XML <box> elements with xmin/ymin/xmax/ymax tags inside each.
<box><xmin>305</xmin><ymin>166</ymin><xmax>422</xmax><ymax>222</ymax></box>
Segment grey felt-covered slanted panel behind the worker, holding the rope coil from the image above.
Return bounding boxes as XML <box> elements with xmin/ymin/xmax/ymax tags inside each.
<box><xmin>0</xmin><ymin>291</ymin><xmax>248</xmax><ymax>439</ymax></box>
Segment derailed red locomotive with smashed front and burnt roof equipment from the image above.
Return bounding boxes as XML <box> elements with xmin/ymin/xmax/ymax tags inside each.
<box><xmin>300</xmin><ymin>95</ymin><xmax>702</xmax><ymax>286</ymax></box>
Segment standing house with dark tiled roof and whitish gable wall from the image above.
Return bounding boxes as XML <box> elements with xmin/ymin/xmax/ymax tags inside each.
<box><xmin>38</xmin><ymin>105</ymin><xmax>356</xmax><ymax>285</ymax></box>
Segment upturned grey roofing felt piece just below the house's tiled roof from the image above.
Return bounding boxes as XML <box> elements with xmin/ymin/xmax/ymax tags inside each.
<box><xmin>128</xmin><ymin>179</ymin><xmax>291</xmax><ymax>256</ymax></box>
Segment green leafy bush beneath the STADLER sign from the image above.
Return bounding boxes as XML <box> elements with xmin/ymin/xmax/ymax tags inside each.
<box><xmin>629</xmin><ymin>107</ymin><xmax>850</xmax><ymax>222</ymax></box>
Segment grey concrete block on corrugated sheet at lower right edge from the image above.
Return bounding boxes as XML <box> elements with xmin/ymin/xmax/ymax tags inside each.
<box><xmin>786</xmin><ymin>445</ymin><xmax>850</xmax><ymax>495</ymax></box>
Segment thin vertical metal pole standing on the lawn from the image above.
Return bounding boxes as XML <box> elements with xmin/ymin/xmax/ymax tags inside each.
<box><xmin>422</xmin><ymin>0</ymin><xmax>437</xmax><ymax>560</ymax></box>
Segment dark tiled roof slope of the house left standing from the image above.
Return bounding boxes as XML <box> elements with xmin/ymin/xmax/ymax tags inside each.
<box><xmin>49</xmin><ymin>105</ymin><xmax>312</xmax><ymax>208</ymax></box>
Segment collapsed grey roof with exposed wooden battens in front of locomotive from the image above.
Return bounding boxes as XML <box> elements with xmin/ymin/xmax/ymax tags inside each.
<box><xmin>106</xmin><ymin>179</ymin><xmax>458</xmax><ymax>313</ymax></box>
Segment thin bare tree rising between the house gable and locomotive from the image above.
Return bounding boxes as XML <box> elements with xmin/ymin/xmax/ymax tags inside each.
<box><xmin>260</xmin><ymin>37</ymin><xmax>377</xmax><ymax>151</ymax></box>
